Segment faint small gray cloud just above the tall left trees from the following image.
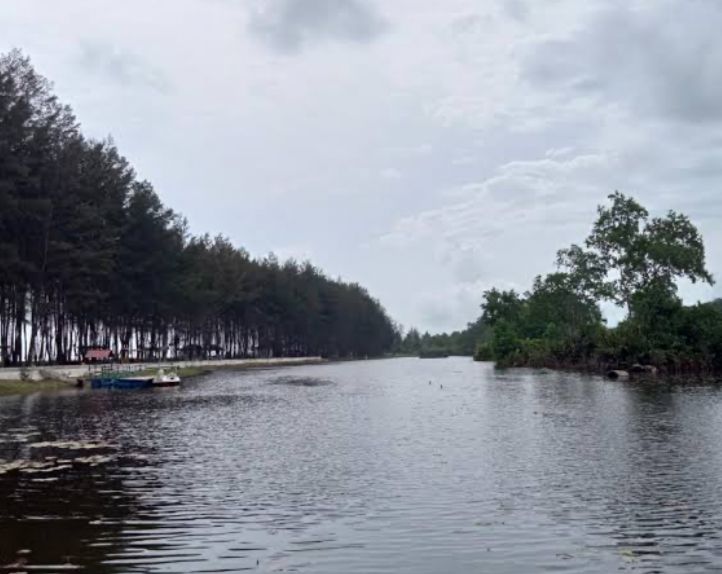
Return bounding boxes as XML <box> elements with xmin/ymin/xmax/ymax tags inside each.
<box><xmin>78</xmin><ymin>42</ymin><xmax>170</xmax><ymax>92</ymax></box>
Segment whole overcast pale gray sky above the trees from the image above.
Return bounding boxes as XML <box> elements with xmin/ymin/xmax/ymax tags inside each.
<box><xmin>0</xmin><ymin>0</ymin><xmax>722</xmax><ymax>332</ymax></box>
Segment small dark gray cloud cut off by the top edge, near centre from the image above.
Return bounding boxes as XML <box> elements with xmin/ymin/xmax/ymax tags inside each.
<box><xmin>250</xmin><ymin>0</ymin><xmax>386</xmax><ymax>53</ymax></box>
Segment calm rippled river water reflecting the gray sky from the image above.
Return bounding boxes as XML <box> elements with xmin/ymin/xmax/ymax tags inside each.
<box><xmin>0</xmin><ymin>359</ymin><xmax>722</xmax><ymax>574</ymax></box>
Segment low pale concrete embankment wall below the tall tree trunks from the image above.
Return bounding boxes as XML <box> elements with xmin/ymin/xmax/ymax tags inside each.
<box><xmin>0</xmin><ymin>357</ymin><xmax>324</xmax><ymax>381</ymax></box>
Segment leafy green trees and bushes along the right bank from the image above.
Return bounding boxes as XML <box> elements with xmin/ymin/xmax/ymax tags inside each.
<box><xmin>404</xmin><ymin>193</ymin><xmax>722</xmax><ymax>374</ymax></box>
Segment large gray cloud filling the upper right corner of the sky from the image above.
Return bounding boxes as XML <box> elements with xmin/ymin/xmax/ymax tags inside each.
<box><xmin>524</xmin><ymin>0</ymin><xmax>722</xmax><ymax>123</ymax></box>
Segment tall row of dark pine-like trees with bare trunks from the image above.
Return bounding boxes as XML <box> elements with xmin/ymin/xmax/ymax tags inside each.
<box><xmin>0</xmin><ymin>51</ymin><xmax>397</xmax><ymax>364</ymax></box>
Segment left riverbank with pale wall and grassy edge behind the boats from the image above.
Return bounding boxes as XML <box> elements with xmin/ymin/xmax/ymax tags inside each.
<box><xmin>0</xmin><ymin>357</ymin><xmax>326</xmax><ymax>396</ymax></box>
